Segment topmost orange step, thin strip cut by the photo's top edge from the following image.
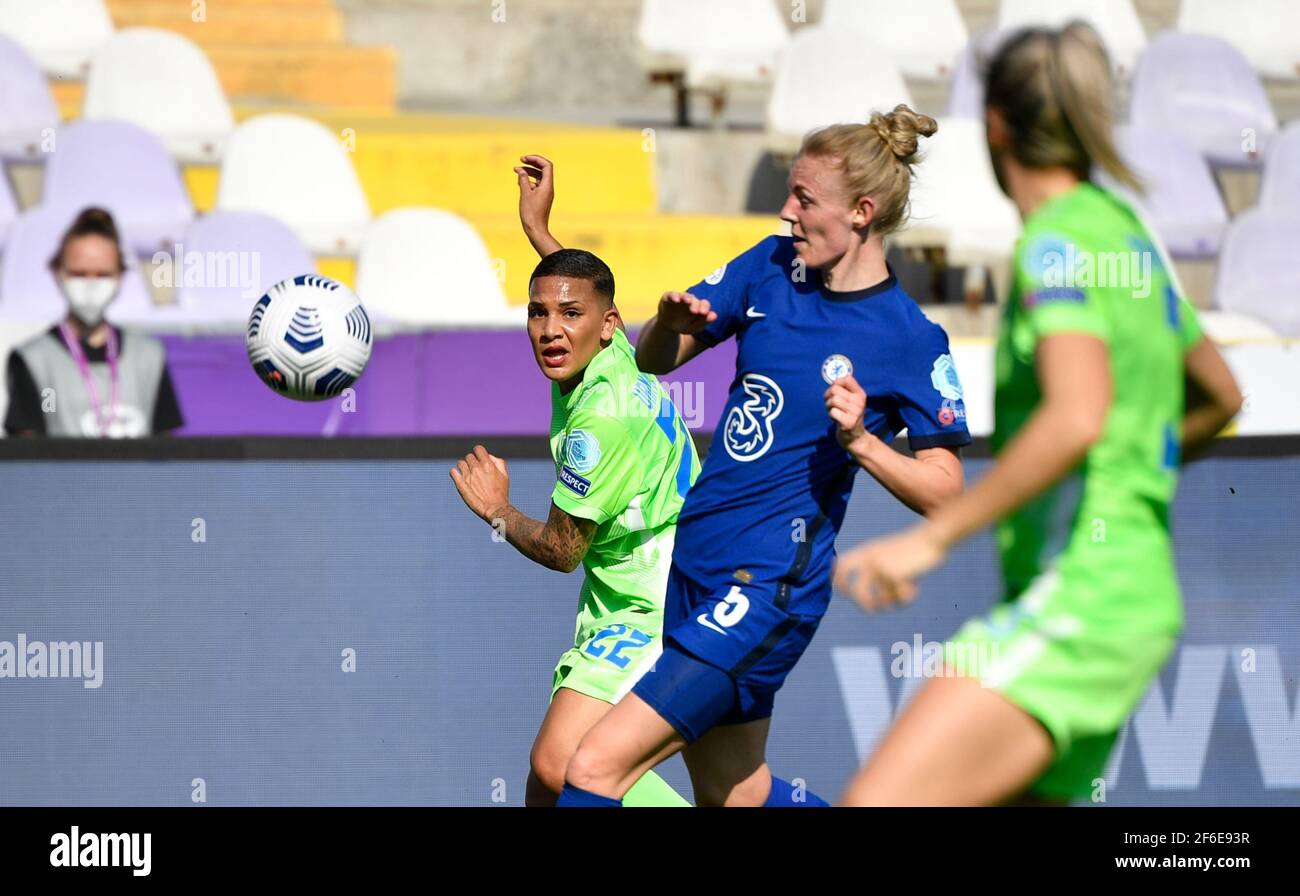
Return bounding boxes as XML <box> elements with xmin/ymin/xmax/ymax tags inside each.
<box><xmin>108</xmin><ymin>0</ymin><xmax>343</xmax><ymax>47</ymax></box>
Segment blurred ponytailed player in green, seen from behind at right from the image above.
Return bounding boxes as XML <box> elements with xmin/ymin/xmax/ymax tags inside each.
<box><xmin>837</xmin><ymin>22</ymin><xmax>1242</xmax><ymax>805</ymax></box>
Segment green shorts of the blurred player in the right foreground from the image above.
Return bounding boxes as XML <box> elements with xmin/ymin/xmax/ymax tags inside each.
<box><xmin>949</xmin><ymin>561</ymin><xmax>1180</xmax><ymax>798</ymax></box>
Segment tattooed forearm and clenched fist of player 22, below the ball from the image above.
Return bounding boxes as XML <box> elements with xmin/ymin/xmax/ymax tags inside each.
<box><xmin>451</xmin><ymin>445</ymin><xmax>595</xmax><ymax>572</ymax></box>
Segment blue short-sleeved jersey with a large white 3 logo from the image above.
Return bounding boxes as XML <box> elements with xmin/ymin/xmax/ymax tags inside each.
<box><xmin>673</xmin><ymin>237</ymin><xmax>971</xmax><ymax>597</ymax></box>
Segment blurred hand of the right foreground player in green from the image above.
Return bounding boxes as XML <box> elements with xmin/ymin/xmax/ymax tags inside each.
<box><xmin>835</xmin><ymin>523</ymin><xmax>946</xmax><ymax>613</ymax></box>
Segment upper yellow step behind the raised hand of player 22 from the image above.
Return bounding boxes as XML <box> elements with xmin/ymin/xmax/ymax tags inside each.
<box><xmin>185</xmin><ymin>107</ymin><xmax>658</xmax><ymax>217</ymax></box>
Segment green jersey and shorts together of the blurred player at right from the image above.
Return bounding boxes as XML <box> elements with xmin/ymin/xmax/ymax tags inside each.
<box><xmin>952</xmin><ymin>182</ymin><xmax>1201</xmax><ymax>798</ymax></box>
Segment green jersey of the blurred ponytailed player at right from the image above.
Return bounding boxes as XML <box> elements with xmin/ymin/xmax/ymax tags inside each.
<box><xmin>993</xmin><ymin>182</ymin><xmax>1201</xmax><ymax>608</ymax></box>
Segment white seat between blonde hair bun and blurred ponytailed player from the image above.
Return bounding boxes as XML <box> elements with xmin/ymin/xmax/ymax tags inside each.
<box><xmin>898</xmin><ymin>117</ymin><xmax>1021</xmax><ymax>264</ymax></box>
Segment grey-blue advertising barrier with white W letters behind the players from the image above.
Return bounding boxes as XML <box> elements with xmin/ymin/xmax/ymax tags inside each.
<box><xmin>0</xmin><ymin>438</ymin><xmax>1300</xmax><ymax>806</ymax></box>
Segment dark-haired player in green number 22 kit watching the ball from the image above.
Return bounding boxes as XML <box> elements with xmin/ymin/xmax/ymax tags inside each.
<box><xmin>451</xmin><ymin>213</ymin><xmax>699</xmax><ymax>806</ymax></box>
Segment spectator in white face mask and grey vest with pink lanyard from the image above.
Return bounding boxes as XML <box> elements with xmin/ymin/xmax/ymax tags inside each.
<box><xmin>4</xmin><ymin>208</ymin><xmax>182</xmax><ymax>438</ymax></box>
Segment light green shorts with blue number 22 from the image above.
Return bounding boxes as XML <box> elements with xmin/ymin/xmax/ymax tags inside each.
<box><xmin>551</xmin><ymin>611</ymin><xmax>663</xmax><ymax>704</ymax></box>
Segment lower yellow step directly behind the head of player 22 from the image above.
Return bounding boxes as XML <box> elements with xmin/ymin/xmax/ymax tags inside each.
<box><xmin>467</xmin><ymin>215</ymin><xmax>781</xmax><ymax>324</ymax></box>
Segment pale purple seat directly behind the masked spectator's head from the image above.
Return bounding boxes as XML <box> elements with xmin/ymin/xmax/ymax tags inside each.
<box><xmin>0</xmin><ymin>205</ymin><xmax>151</xmax><ymax>323</ymax></box>
